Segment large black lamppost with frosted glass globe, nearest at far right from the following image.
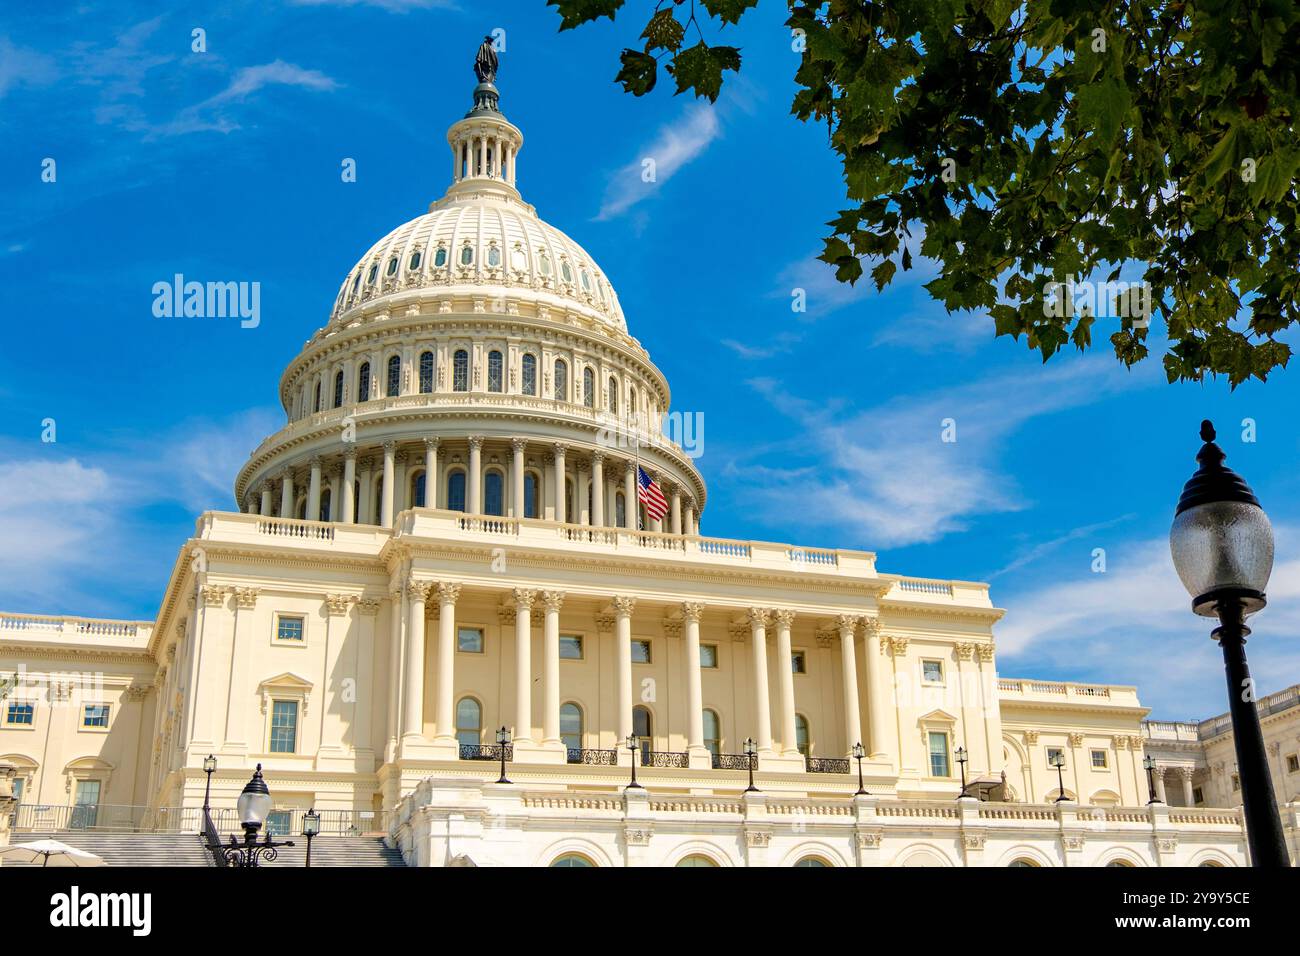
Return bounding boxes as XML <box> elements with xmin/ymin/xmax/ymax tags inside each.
<box><xmin>1169</xmin><ymin>421</ymin><xmax>1291</xmax><ymax>868</ymax></box>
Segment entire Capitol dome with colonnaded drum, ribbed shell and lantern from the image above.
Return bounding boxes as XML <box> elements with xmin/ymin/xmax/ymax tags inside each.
<box><xmin>235</xmin><ymin>70</ymin><xmax>705</xmax><ymax>535</ymax></box>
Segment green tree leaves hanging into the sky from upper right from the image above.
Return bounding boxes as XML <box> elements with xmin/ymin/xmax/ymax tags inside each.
<box><xmin>547</xmin><ymin>0</ymin><xmax>1300</xmax><ymax>386</ymax></box>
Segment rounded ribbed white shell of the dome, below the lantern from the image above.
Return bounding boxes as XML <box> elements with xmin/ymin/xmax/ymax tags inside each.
<box><xmin>332</xmin><ymin>195</ymin><xmax>628</xmax><ymax>333</ymax></box>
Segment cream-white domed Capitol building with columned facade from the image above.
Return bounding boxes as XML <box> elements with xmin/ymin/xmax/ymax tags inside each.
<box><xmin>0</xmin><ymin>57</ymin><xmax>1268</xmax><ymax>866</ymax></box>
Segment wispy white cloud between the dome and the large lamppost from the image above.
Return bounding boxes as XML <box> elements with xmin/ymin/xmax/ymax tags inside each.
<box><xmin>737</xmin><ymin>356</ymin><xmax>1140</xmax><ymax>548</ymax></box>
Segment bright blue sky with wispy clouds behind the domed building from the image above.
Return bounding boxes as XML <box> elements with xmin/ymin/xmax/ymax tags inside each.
<box><xmin>0</xmin><ymin>0</ymin><xmax>1300</xmax><ymax>718</ymax></box>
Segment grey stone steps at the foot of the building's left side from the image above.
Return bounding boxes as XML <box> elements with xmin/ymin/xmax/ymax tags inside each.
<box><xmin>5</xmin><ymin>830</ymin><xmax>406</xmax><ymax>869</ymax></box>
